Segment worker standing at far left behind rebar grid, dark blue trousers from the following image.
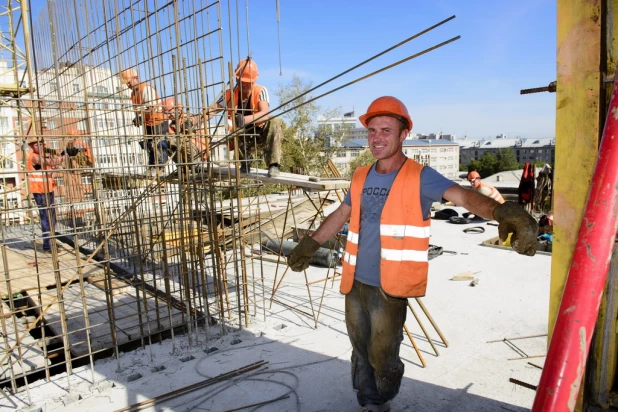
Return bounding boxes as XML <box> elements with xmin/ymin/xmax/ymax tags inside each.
<box><xmin>26</xmin><ymin>136</ymin><xmax>66</xmax><ymax>252</ymax></box>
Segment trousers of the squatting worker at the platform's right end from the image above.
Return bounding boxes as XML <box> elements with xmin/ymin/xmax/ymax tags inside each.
<box><xmin>238</xmin><ymin>118</ymin><xmax>283</xmax><ymax>166</ymax></box>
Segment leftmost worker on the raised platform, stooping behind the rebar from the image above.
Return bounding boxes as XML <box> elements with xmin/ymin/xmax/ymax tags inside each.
<box><xmin>120</xmin><ymin>69</ymin><xmax>169</xmax><ymax>166</ymax></box>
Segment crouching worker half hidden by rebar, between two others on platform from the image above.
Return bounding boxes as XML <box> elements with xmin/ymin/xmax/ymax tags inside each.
<box><xmin>162</xmin><ymin>97</ymin><xmax>210</xmax><ymax>164</ymax></box>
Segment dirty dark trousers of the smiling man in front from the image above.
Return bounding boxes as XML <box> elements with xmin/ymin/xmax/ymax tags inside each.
<box><xmin>345</xmin><ymin>281</ymin><xmax>407</xmax><ymax>406</ymax></box>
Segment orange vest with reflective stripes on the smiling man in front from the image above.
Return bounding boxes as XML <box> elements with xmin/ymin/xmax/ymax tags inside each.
<box><xmin>340</xmin><ymin>159</ymin><xmax>431</xmax><ymax>298</ymax></box>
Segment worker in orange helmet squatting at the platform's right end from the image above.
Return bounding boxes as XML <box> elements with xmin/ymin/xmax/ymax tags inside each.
<box><xmin>206</xmin><ymin>57</ymin><xmax>283</xmax><ymax>177</ymax></box>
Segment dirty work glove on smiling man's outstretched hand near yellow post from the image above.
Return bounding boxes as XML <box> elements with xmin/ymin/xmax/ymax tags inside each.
<box><xmin>494</xmin><ymin>202</ymin><xmax>539</xmax><ymax>256</ymax></box>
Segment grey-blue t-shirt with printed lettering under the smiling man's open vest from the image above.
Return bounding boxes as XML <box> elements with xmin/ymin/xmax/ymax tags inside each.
<box><xmin>343</xmin><ymin>164</ymin><xmax>456</xmax><ymax>286</ymax></box>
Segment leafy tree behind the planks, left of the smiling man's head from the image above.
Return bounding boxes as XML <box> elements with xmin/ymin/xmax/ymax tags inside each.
<box><xmin>276</xmin><ymin>75</ymin><xmax>344</xmax><ymax>175</ymax></box>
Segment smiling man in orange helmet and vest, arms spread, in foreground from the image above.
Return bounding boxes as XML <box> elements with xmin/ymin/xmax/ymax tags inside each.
<box><xmin>288</xmin><ymin>96</ymin><xmax>538</xmax><ymax>412</ymax></box>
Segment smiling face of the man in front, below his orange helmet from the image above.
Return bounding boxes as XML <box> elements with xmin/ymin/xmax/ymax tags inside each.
<box><xmin>367</xmin><ymin>116</ymin><xmax>408</xmax><ymax>160</ymax></box>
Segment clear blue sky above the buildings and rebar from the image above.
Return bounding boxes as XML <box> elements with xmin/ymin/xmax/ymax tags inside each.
<box><xmin>27</xmin><ymin>0</ymin><xmax>556</xmax><ymax>138</ymax></box>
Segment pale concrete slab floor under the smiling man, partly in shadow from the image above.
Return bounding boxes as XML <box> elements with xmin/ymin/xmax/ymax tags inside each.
<box><xmin>0</xmin><ymin>208</ymin><xmax>551</xmax><ymax>412</ymax></box>
